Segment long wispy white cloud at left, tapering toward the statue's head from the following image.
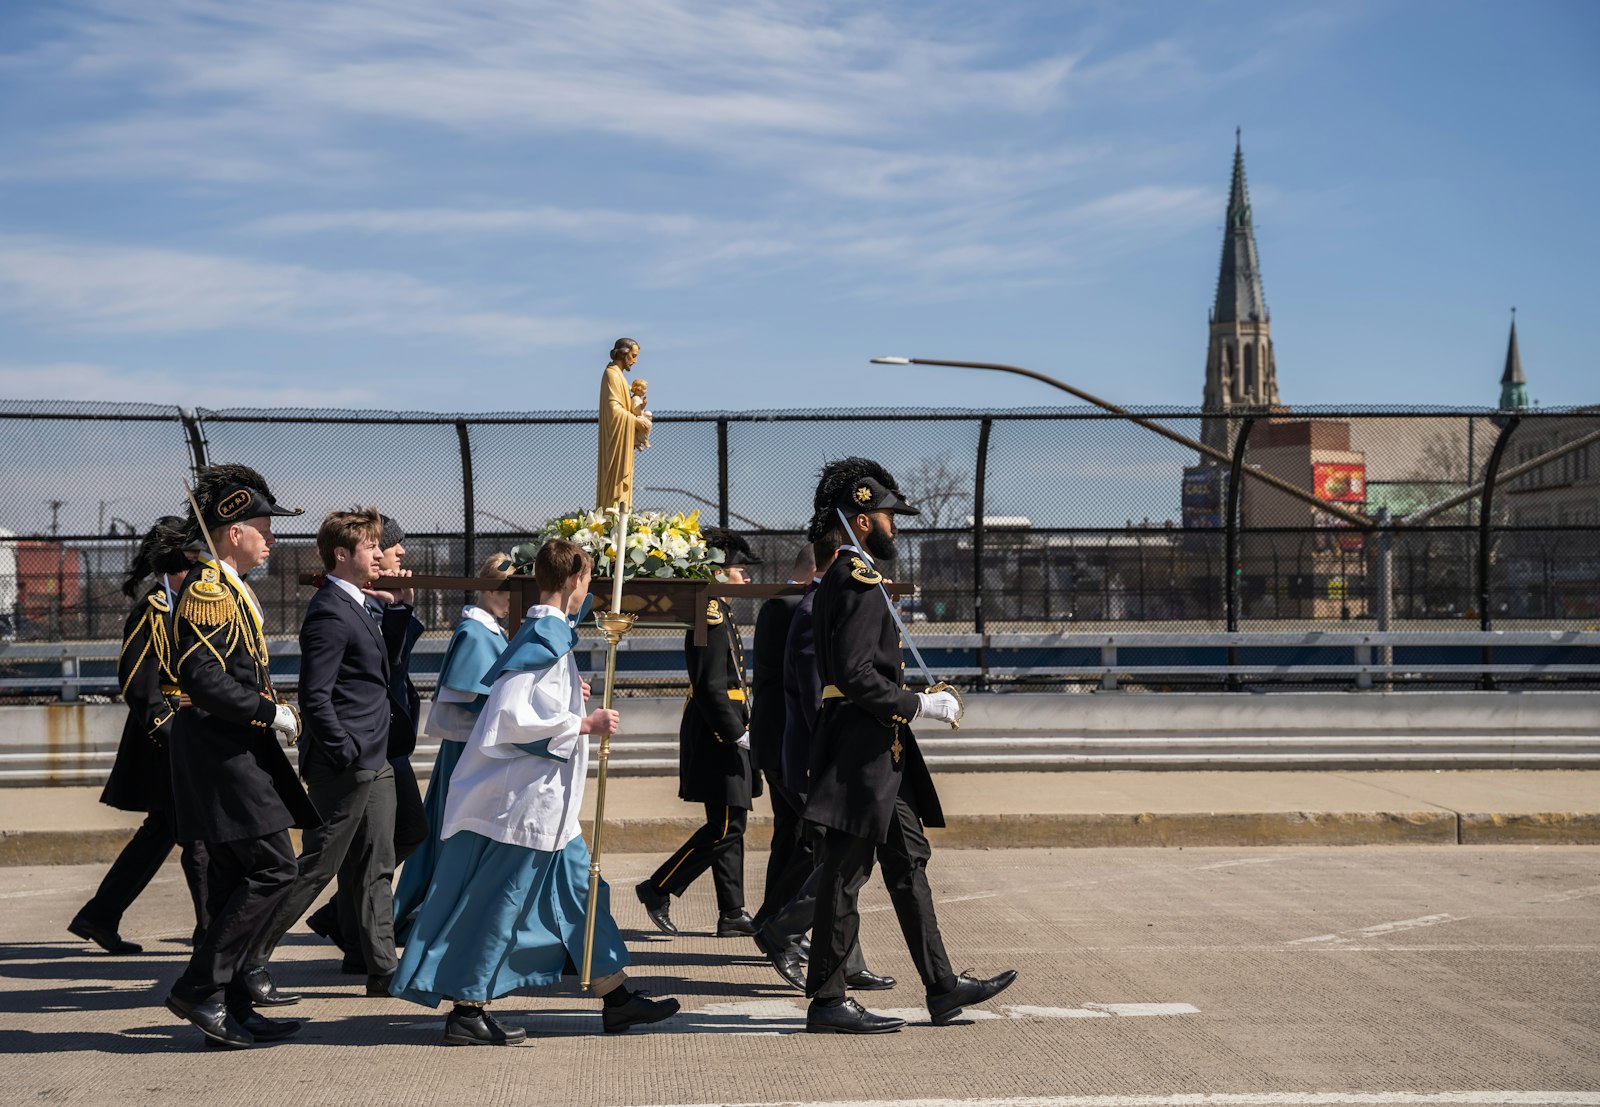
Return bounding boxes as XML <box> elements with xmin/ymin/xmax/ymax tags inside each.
<box><xmin>0</xmin><ymin>235</ymin><xmax>606</xmax><ymax>349</ymax></box>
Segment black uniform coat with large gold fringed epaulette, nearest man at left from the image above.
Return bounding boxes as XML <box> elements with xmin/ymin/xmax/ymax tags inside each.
<box><xmin>171</xmin><ymin>561</ymin><xmax>322</xmax><ymax>841</ymax></box>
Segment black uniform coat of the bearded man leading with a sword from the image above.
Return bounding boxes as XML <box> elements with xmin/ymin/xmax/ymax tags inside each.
<box><xmin>805</xmin><ymin>546</ymin><xmax>944</xmax><ymax>841</ymax></box>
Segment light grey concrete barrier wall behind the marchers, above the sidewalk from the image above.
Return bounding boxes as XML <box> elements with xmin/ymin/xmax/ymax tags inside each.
<box><xmin>0</xmin><ymin>691</ymin><xmax>1600</xmax><ymax>785</ymax></box>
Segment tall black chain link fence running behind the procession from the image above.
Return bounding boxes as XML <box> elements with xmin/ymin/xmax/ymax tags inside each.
<box><xmin>0</xmin><ymin>403</ymin><xmax>1600</xmax><ymax>687</ymax></box>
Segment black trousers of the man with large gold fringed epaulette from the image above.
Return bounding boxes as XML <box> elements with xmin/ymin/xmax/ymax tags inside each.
<box><xmin>173</xmin><ymin>830</ymin><xmax>298</xmax><ymax>1006</ymax></box>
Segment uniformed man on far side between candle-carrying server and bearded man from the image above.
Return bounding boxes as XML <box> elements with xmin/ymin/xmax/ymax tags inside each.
<box><xmin>634</xmin><ymin>526</ymin><xmax>762</xmax><ymax>937</ymax></box>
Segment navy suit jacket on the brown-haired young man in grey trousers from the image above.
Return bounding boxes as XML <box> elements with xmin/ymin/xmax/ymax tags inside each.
<box><xmin>299</xmin><ymin>581</ymin><xmax>394</xmax><ymax>773</ymax></box>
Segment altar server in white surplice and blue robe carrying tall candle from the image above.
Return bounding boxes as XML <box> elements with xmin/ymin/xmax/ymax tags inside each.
<box><xmin>390</xmin><ymin>539</ymin><xmax>678</xmax><ymax>1046</ymax></box>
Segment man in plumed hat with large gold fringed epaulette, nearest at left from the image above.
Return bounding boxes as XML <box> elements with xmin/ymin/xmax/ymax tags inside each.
<box><xmin>166</xmin><ymin>466</ymin><xmax>322</xmax><ymax>1048</ymax></box>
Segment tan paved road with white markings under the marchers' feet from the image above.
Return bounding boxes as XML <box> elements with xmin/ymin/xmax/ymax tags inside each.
<box><xmin>0</xmin><ymin>846</ymin><xmax>1600</xmax><ymax>1107</ymax></box>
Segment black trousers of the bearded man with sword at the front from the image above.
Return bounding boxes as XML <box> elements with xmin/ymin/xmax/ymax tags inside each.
<box><xmin>805</xmin><ymin>795</ymin><xmax>950</xmax><ymax>1000</ymax></box>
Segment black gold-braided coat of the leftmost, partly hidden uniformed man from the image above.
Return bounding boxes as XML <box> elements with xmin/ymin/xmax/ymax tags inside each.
<box><xmin>101</xmin><ymin>584</ymin><xmax>178</xmax><ymax>811</ymax></box>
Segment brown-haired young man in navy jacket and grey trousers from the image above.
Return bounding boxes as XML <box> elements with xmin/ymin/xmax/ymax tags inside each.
<box><xmin>250</xmin><ymin>509</ymin><xmax>406</xmax><ymax>1003</ymax></box>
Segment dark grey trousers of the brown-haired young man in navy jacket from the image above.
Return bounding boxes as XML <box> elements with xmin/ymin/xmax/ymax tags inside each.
<box><xmin>250</xmin><ymin>761</ymin><xmax>398</xmax><ymax>973</ymax></box>
